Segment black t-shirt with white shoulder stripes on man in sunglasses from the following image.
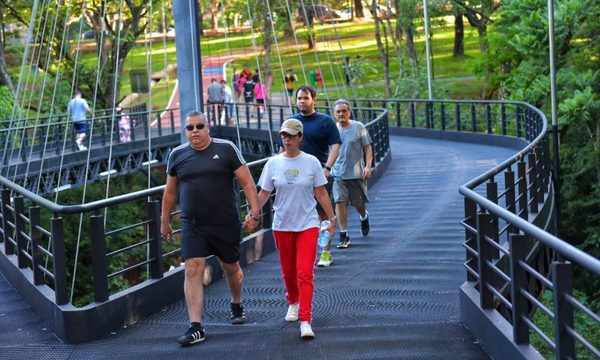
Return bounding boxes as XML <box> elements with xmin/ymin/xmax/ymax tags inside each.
<box><xmin>167</xmin><ymin>138</ymin><xmax>246</xmax><ymax>225</ymax></box>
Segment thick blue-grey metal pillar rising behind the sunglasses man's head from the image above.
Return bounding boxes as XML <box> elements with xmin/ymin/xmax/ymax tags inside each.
<box><xmin>172</xmin><ymin>0</ymin><xmax>204</xmax><ymax>142</ymax></box>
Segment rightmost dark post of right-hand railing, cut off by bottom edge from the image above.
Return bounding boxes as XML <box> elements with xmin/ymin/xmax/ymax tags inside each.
<box><xmin>552</xmin><ymin>261</ymin><xmax>576</xmax><ymax>360</ymax></box>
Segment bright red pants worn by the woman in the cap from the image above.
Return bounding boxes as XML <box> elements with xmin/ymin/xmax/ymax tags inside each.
<box><xmin>273</xmin><ymin>227</ymin><xmax>319</xmax><ymax>322</ymax></box>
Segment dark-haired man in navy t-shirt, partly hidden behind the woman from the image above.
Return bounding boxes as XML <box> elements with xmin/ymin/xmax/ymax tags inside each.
<box><xmin>293</xmin><ymin>85</ymin><xmax>342</xmax><ymax>267</ymax></box>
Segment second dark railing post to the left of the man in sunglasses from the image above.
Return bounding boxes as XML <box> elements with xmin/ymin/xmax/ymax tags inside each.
<box><xmin>90</xmin><ymin>215</ymin><xmax>108</xmax><ymax>302</ymax></box>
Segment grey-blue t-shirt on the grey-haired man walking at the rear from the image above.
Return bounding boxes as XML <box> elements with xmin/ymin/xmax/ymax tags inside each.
<box><xmin>331</xmin><ymin>120</ymin><xmax>371</xmax><ymax>180</ymax></box>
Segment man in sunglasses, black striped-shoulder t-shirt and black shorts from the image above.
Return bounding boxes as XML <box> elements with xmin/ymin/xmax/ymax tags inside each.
<box><xmin>160</xmin><ymin>111</ymin><xmax>260</xmax><ymax>345</ymax></box>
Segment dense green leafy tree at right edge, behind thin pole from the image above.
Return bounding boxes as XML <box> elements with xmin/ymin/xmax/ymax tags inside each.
<box><xmin>479</xmin><ymin>0</ymin><xmax>600</xmax><ymax>309</ymax></box>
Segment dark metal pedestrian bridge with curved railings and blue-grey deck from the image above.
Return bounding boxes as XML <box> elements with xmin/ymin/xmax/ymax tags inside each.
<box><xmin>0</xmin><ymin>100</ymin><xmax>600</xmax><ymax>359</ymax></box>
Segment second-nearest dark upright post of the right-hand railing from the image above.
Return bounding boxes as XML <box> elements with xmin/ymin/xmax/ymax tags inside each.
<box><xmin>508</xmin><ymin>234</ymin><xmax>529</xmax><ymax>344</ymax></box>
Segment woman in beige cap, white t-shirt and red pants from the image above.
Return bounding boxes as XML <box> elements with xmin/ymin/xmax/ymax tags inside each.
<box><xmin>251</xmin><ymin>119</ymin><xmax>336</xmax><ymax>338</ymax></box>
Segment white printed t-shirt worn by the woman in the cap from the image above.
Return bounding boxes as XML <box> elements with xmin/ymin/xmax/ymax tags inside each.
<box><xmin>258</xmin><ymin>152</ymin><xmax>327</xmax><ymax>231</ymax></box>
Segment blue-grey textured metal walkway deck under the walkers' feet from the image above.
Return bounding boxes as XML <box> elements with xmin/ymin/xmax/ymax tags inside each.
<box><xmin>0</xmin><ymin>136</ymin><xmax>514</xmax><ymax>359</ymax></box>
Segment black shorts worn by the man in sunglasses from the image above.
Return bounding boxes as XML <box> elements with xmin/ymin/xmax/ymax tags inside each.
<box><xmin>181</xmin><ymin>217</ymin><xmax>242</xmax><ymax>264</ymax></box>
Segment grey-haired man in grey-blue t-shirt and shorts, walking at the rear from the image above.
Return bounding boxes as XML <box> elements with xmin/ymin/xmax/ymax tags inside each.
<box><xmin>331</xmin><ymin>99</ymin><xmax>373</xmax><ymax>249</ymax></box>
